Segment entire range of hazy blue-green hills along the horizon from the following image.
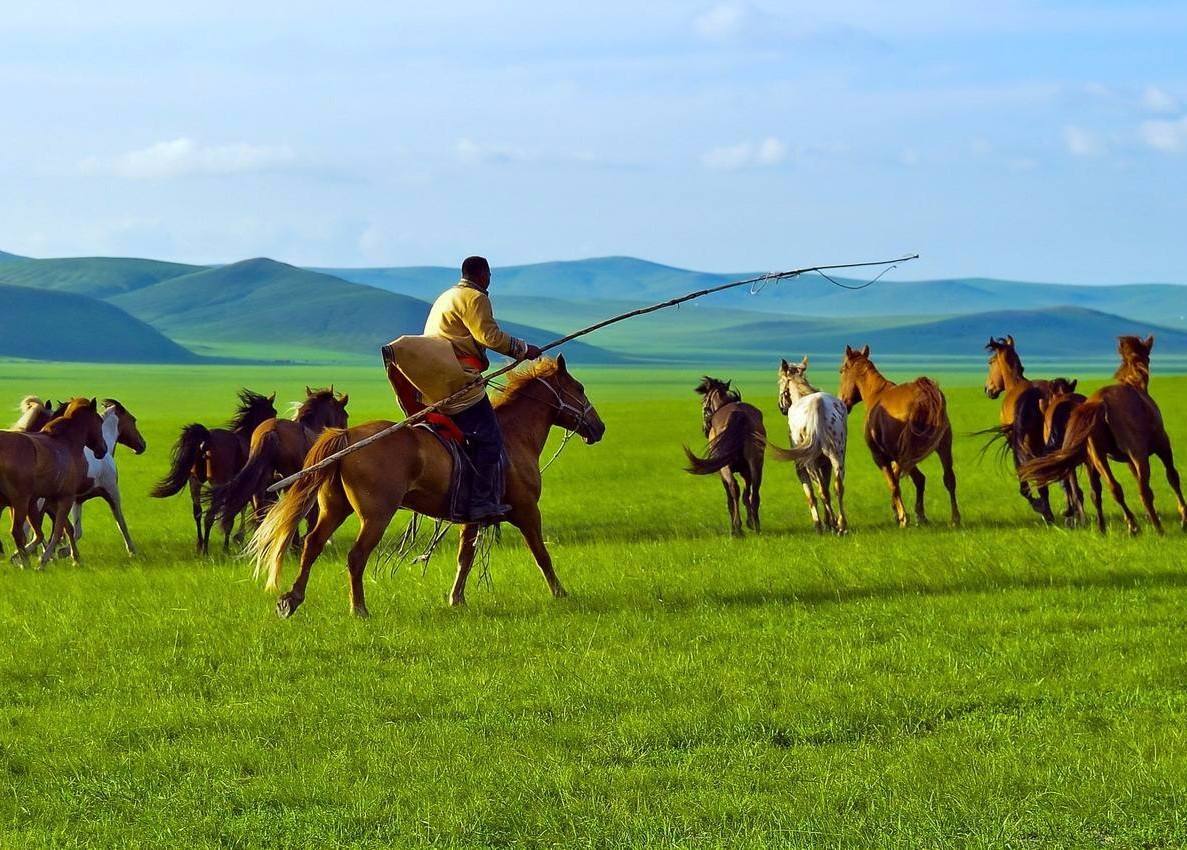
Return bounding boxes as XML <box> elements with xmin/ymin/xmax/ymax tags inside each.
<box><xmin>0</xmin><ymin>252</ymin><xmax>1187</xmax><ymax>363</ymax></box>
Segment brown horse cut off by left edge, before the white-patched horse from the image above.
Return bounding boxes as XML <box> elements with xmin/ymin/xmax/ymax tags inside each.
<box><xmin>0</xmin><ymin>399</ymin><xmax>107</xmax><ymax>566</ymax></box>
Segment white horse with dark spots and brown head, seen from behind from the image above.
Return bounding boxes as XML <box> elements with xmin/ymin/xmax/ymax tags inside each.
<box><xmin>769</xmin><ymin>356</ymin><xmax>849</xmax><ymax>534</ymax></box>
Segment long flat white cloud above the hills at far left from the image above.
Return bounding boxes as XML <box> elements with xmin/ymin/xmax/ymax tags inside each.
<box><xmin>80</xmin><ymin>137</ymin><xmax>297</xmax><ymax>180</ymax></box>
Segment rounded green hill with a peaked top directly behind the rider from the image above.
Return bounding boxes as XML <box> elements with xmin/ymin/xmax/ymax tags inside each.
<box><xmin>112</xmin><ymin>258</ymin><xmax>621</xmax><ymax>362</ymax></box>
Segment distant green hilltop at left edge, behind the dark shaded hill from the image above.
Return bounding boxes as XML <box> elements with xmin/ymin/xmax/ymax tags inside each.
<box><xmin>0</xmin><ymin>256</ymin><xmax>202</xmax><ymax>298</ymax></box>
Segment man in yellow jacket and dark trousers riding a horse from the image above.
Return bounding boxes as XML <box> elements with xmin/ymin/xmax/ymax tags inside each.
<box><xmin>425</xmin><ymin>256</ymin><xmax>541</xmax><ymax>522</ymax></box>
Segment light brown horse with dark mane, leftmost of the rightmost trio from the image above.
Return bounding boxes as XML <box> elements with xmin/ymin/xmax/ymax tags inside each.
<box><xmin>985</xmin><ymin>335</ymin><xmax>1084</xmax><ymax>525</ymax></box>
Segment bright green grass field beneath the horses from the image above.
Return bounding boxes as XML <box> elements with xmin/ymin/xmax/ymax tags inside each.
<box><xmin>0</xmin><ymin>360</ymin><xmax>1187</xmax><ymax>848</ymax></box>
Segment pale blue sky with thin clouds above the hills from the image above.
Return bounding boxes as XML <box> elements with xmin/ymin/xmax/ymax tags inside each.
<box><xmin>0</xmin><ymin>0</ymin><xmax>1187</xmax><ymax>283</ymax></box>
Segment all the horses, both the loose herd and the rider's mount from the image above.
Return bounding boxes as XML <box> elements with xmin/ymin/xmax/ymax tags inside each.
<box><xmin>0</xmin><ymin>336</ymin><xmax>1187</xmax><ymax>617</ymax></box>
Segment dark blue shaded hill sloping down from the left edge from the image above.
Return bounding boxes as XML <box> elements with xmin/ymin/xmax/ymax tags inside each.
<box><xmin>0</xmin><ymin>285</ymin><xmax>199</xmax><ymax>363</ymax></box>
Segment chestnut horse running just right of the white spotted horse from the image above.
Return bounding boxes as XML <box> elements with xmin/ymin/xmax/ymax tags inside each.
<box><xmin>837</xmin><ymin>345</ymin><xmax>960</xmax><ymax>528</ymax></box>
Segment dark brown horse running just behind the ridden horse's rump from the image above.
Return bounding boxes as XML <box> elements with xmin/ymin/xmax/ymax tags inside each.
<box><xmin>210</xmin><ymin>385</ymin><xmax>350</xmax><ymax>538</ymax></box>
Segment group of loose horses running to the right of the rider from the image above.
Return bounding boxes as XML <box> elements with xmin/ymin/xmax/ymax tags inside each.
<box><xmin>685</xmin><ymin>336</ymin><xmax>1187</xmax><ymax>534</ymax></box>
